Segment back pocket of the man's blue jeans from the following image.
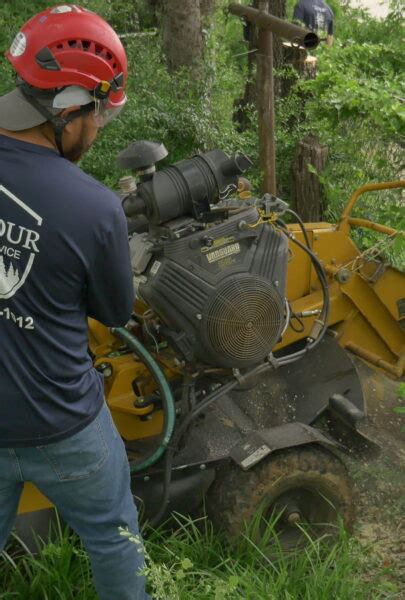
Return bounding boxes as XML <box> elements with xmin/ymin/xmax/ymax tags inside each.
<box><xmin>38</xmin><ymin>416</ymin><xmax>109</xmax><ymax>481</ymax></box>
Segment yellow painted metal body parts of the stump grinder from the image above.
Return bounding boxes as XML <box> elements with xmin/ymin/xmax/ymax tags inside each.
<box><xmin>19</xmin><ymin>182</ymin><xmax>405</xmax><ymax>513</ymax></box>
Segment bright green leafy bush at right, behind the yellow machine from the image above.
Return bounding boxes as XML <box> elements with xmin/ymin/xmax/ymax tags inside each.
<box><xmin>278</xmin><ymin>0</ymin><xmax>405</xmax><ymax>269</ymax></box>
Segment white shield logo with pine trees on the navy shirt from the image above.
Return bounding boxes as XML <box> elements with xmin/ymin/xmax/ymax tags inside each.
<box><xmin>0</xmin><ymin>185</ymin><xmax>42</xmax><ymax>300</ymax></box>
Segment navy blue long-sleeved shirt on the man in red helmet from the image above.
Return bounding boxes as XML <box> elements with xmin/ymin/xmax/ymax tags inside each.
<box><xmin>0</xmin><ymin>135</ymin><xmax>134</xmax><ymax>447</ymax></box>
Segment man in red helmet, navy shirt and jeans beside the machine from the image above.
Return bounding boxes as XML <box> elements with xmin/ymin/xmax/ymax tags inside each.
<box><xmin>0</xmin><ymin>4</ymin><xmax>148</xmax><ymax>600</ymax></box>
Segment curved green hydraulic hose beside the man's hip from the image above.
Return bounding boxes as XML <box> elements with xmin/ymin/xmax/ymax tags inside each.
<box><xmin>111</xmin><ymin>327</ymin><xmax>176</xmax><ymax>473</ymax></box>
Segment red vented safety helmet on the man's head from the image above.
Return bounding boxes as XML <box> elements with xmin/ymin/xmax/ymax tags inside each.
<box><xmin>6</xmin><ymin>4</ymin><xmax>127</xmax><ymax>107</ymax></box>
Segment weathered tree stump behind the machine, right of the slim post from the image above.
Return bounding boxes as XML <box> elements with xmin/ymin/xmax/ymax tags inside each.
<box><xmin>291</xmin><ymin>135</ymin><xmax>328</xmax><ymax>223</ymax></box>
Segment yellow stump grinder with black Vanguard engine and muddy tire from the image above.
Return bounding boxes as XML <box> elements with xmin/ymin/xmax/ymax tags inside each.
<box><xmin>18</xmin><ymin>142</ymin><xmax>405</xmax><ymax>542</ymax></box>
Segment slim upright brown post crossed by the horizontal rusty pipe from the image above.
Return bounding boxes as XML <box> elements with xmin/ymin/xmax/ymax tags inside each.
<box><xmin>257</xmin><ymin>0</ymin><xmax>277</xmax><ymax>195</ymax></box>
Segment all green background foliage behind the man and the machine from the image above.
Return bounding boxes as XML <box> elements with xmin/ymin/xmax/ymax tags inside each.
<box><xmin>0</xmin><ymin>0</ymin><xmax>405</xmax><ymax>266</ymax></box>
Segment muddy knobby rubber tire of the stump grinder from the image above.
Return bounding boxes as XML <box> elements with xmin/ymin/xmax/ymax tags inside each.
<box><xmin>206</xmin><ymin>444</ymin><xmax>354</xmax><ymax>539</ymax></box>
